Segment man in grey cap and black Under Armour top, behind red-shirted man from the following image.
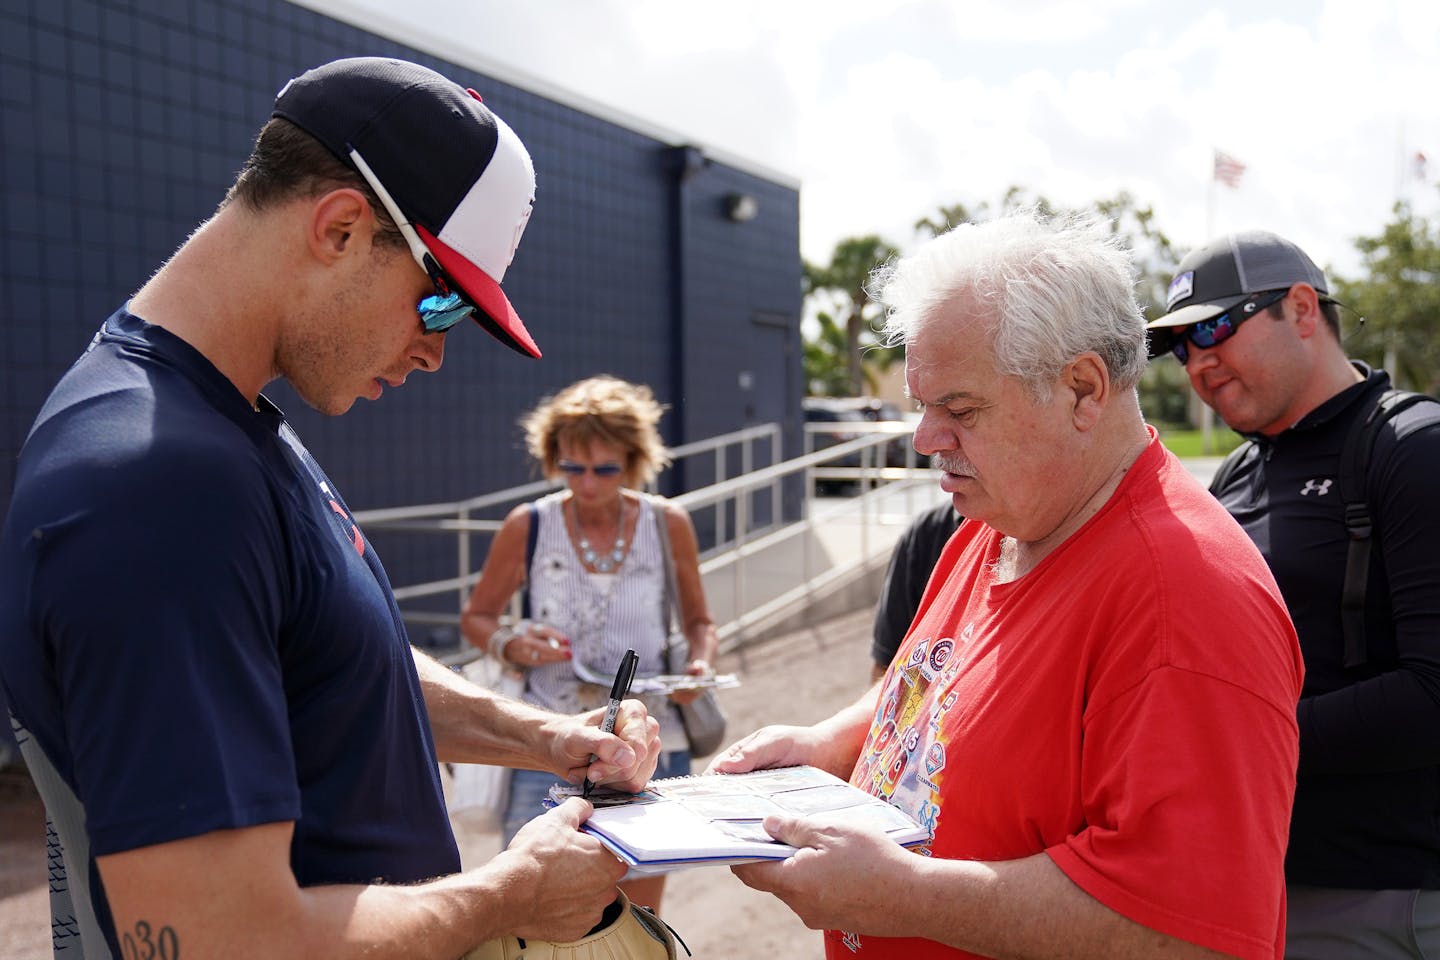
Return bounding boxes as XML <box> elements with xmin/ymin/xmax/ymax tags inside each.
<box><xmin>1149</xmin><ymin>232</ymin><xmax>1440</xmax><ymax>959</ymax></box>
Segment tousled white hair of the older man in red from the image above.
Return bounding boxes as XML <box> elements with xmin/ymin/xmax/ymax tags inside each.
<box><xmin>870</xmin><ymin>207</ymin><xmax>1146</xmax><ymax>402</ymax></box>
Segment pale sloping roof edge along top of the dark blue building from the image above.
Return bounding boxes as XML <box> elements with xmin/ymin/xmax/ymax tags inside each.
<box><xmin>280</xmin><ymin>0</ymin><xmax>801</xmax><ymax>191</ymax></box>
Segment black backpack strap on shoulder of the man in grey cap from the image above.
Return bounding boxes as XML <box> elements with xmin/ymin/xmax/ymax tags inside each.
<box><xmin>1338</xmin><ymin>390</ymin><xmax>1434</xmax><ymax>669</ymax></box>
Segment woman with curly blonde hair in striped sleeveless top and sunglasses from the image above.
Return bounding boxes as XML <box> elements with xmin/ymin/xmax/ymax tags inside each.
<box><xmin>461</xmin><ymin>376</ymin><xmax>717</xmax><ymax>910</ymax></box>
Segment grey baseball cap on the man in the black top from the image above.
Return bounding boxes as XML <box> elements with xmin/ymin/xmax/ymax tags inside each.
<box><xmin>1146</xmin><ymin>230</ymin><xmax>1329</xmax><ymax>330</ymax></box>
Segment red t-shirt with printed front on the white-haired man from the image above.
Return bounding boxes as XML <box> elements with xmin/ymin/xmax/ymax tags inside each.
<box><xmin>825</xmin><ymin>439</ymin><xmax>1303</xmax><ymax>960</ymax></box>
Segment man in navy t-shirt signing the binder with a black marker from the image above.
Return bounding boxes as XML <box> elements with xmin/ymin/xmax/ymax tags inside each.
<box><xmin>0</xmin><ymin>58</ymin><xmax>658</xmax><ymax>960</ymax></box>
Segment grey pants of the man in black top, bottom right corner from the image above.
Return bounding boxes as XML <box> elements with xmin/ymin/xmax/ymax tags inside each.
<box><xmin>1284</xmin><ymin>884</ymin><xmax>1440</xmax><ymax>960</ymax></box>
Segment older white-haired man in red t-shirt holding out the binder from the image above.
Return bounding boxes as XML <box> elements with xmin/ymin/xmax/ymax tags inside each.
<box><xmin>711</xmin><ymin>212</ymin><xmax>1303</xmax><ymax>960</ymax></box>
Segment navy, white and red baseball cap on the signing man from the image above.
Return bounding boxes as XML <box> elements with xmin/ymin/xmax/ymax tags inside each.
<box><xmin>272</xmin><ymin>56</ymin><xmax>540</xmax><ymax>357</ymax></box>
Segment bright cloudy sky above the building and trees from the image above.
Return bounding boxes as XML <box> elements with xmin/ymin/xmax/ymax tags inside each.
<box><xmin>324</xmin><ymin>0</ymin><xmax>1440</xmax><ymax>272</ymax></box>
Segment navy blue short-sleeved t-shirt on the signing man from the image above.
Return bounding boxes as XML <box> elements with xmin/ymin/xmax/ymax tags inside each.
<box><xmin>0</xmin><ymin>309</ymin><xmax>459</xmax><ymax>941</ymax></box>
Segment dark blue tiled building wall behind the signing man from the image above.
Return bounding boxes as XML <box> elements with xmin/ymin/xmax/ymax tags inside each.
<box><xmin>0</xmin><ymin>0</ymin><xmax>802</xmax><ymax>583</ymax></box>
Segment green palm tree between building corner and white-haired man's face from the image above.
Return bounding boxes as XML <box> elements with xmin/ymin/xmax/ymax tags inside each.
<box><xmin>804</xmin><ymin>235</ymin><xmax>900</xmax><ymax>396</ymax></box>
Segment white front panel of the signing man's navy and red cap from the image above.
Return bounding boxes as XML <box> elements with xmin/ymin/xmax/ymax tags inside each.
<box><xmin>439</xmin><ymin>117</ymin><xmax>536</xmax><ymax>284</ymax></box>
